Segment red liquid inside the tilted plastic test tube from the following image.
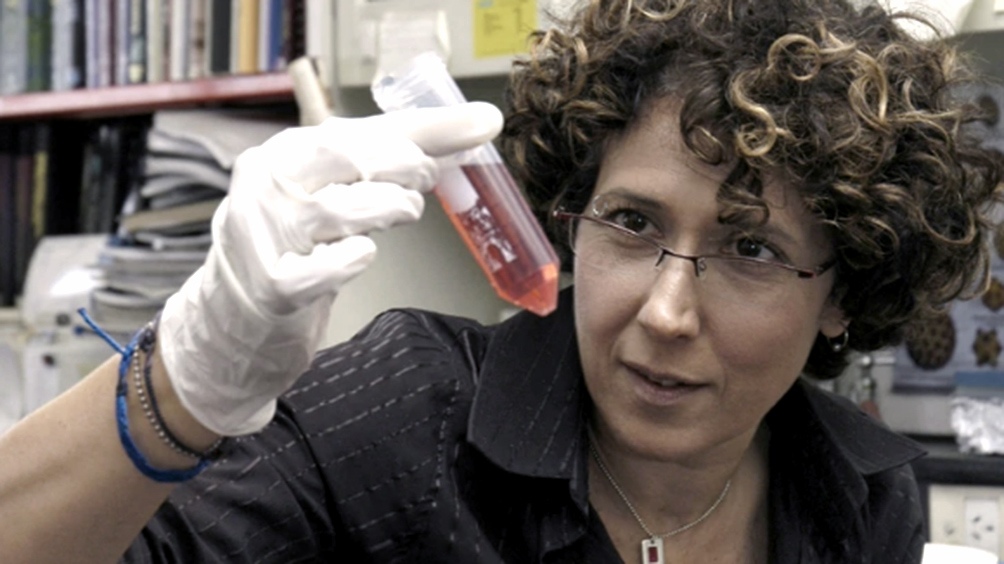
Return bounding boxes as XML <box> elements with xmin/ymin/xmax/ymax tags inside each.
<box><xmin>441</xmin><ymin>163</ymin><xmax>558</xmax><ymax>315</ymax></box>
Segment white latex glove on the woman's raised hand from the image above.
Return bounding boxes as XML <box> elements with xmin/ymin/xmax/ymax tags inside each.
<box><xmin>159</xmin><ymin>102</ymin><xmax>502</xmax><ymax>436</ymax></box>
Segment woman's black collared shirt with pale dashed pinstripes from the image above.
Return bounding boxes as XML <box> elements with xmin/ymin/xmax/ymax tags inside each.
<box><xmin>124</xmin><ymin>291</ymin><xmax>924</xmax><ymax>564</ymax></box>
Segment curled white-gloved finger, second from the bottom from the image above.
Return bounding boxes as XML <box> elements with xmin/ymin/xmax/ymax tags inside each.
<box><xmin>297</xmin><ymin>182</ymin><xmax>426</xmax><ymax>241</ymax></box>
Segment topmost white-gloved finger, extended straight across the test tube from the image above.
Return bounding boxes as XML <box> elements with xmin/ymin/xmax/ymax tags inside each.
<box><xmin>375</xmin><ymin>101</ymin><xmax>502</xmax><ymax>157</ymax></box>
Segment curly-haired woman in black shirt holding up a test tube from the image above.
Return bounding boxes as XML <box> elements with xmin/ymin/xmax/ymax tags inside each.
<box><xmin>0</xmin><ymin>0</ymin><xmax>999</xmax><ymax>563</ymax></box>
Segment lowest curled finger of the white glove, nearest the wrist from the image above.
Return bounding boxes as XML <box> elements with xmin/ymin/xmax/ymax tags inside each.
<box><xmin>269</xmin><ymin>235</ymin><xmax>377</xmax><ymax>310</ymax></box>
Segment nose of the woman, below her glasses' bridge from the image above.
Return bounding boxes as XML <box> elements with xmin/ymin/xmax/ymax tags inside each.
<box><xmin>638</xmin><ymin>255</ymin><xmax>702</xmax><ymax>338</ymax></box>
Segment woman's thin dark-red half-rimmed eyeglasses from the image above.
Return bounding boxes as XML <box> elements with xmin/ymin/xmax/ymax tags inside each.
<box><xmin>552</xmin><ymin>202</ymin><xmax>836</xmax><ymax>307</ymax></box>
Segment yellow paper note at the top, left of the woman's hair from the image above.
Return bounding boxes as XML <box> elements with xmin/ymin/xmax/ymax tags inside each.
<box><xmin>473</xmin><ymin>0</ymin><xmax>537</xmax><ymax>59</ymax></box>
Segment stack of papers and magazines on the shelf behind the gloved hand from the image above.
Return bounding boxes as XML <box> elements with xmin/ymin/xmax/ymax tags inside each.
<box><xmin>90</xmin><ymin>109</ymin><xmax>296</xmax><ymax>330</ymax></box>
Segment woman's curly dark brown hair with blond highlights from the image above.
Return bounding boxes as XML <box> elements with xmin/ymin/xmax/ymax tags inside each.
<box><xmin>500</xmin><ymin>0</ymin><xmax>1001</xmax><ymax>378</ymax></box>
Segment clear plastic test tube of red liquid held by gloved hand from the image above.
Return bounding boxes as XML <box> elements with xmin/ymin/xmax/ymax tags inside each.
<box><xmin>372</xmin><ymin>52</ymin><xmax>558</xmax><ymax>315</ymax></box>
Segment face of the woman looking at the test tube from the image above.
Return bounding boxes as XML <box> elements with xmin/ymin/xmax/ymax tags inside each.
<box><xmin>574</xmin><ymin>106</ymin><xmax>843</xmax><ymax>464</ymax></box>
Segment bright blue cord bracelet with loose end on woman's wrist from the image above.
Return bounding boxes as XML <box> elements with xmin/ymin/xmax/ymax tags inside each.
<box><xmin>77</xmin><ymin>308</ymin><xmax>212</xmax><ymax>484</ymax></box>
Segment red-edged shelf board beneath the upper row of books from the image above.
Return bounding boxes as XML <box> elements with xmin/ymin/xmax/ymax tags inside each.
<box><xmin>0</xmin><ymin>72</ymin><xmax>293</xmax><ymax>121</ymax></box>
